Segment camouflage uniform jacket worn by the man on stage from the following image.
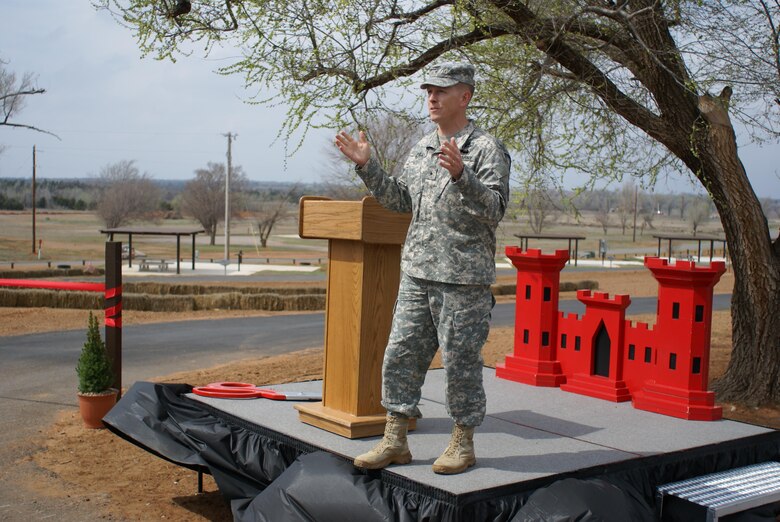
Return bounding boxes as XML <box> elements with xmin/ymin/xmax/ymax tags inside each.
<box><xmin>357</xmin><ymin>122</ymin><xmax>511</xmax><ymax>284</ymax></box>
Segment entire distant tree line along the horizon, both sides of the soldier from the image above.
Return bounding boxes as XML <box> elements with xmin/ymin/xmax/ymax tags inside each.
<box><xmin>0</xmin><ymin>166</ymin><xmax>780</xmax><ymax>241</ymax></box>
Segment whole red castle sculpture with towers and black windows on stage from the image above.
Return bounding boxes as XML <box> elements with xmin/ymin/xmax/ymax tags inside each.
<box><xmin>496</xmin><ymin>247</ymin><xmax>726</xmax><ymax>420</ymax></box>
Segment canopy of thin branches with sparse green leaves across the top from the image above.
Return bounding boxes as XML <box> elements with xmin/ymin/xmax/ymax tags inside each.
<box><xmin>97</xmin><ymin>0</ymin><xmax>780</xmax><ymax>187</ymax></box>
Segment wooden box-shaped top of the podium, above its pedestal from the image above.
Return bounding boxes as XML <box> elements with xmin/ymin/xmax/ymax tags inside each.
<box><xmin>298</xmin><ymin>196</ymin><xmax>411</xmax><ymax>245</ymax></box>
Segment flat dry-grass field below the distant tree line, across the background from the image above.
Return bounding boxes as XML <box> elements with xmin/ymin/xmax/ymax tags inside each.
<box><xmin>0</xmin><ymin>206</ymin><xmax>744</xmax><ymax>265</ymax></box>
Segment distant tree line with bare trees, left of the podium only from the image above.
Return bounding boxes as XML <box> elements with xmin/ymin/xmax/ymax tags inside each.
<box><xmin>0</xmin><ymin>160</ymin><xmax>323</xmax><ymax>248</ymax></box>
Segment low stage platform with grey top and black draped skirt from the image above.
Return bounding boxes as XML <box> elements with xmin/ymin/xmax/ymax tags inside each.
<box><xmin>105</xmin><ymin>368</ymin><xmax>780</xmax><ymax>520</ymax></box>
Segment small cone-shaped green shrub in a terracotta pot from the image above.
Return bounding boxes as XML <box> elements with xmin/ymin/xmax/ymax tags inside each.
<box><xmin>76</xmin><ymin>312</ymin><xmax>118</xmax><ymax>428</ymax></box>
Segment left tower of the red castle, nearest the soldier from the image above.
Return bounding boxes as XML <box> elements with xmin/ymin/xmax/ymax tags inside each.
<box><xmin>496</xmin><ymin>246</ymin><xmax>569</xmax><ymax>386</ymax></box>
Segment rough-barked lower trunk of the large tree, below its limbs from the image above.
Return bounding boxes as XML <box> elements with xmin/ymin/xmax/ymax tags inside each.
<box><xmin>697</xmin><ymin>92</ymin><xmax>780</xmax><ymax>405</ymax></box>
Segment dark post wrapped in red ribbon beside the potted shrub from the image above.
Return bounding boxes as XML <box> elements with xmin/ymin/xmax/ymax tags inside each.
<box><xmin>103</xmin><ymin>241</ymin><xmax>122</xmax><ymax>396</ymax></box>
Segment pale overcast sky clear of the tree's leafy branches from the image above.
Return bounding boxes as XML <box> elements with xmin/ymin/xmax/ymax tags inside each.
<box><xmin>0</xmin><ymin>0</ymin><xmax>780</xmax><ymax>198</ymax></box>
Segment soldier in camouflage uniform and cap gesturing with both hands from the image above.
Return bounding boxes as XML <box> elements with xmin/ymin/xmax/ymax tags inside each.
<box><xmin>336</xmin><ymin>63</ymin><xmax>510</xmax><ymax>474</ymax></box>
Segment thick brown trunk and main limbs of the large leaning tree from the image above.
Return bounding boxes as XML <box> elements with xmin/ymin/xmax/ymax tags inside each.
<box><xmin>492</xmin><ymin>0</ymin><xmax>780</xmax><ymax>404</ymax></box>
